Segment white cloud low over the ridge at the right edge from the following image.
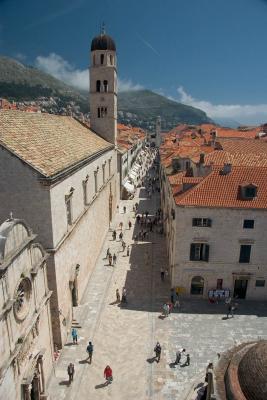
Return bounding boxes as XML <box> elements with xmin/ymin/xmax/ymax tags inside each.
<box><xmin>177</xmin><ymin>86</ymin><xmax>267</xmax><ymax>124</ymax></box>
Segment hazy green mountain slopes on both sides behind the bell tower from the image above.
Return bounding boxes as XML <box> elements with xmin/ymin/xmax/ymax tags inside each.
<box><xmin>0</xmin><ymin>57</ymin><xmax>214</xmax><ymax>130</ymax></box>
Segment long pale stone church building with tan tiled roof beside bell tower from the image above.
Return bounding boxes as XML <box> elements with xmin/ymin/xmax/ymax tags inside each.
<box><xmin>0</xmin><ymin>110</ymin><xmax>118</xmax><ymax>347</ymax></box>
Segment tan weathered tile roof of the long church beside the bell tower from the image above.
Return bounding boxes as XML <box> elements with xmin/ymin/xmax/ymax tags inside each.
<box><xmin>0</xmin><ymin>110</ymin><xmax>113</xmax><ymax>176</ymax></box>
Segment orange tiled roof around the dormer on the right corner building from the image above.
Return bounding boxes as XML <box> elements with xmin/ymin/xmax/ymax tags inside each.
<box><xmin>175</xmin><ymin>167</ymin><xmax>267</xmax><ymax>209</ymax></box>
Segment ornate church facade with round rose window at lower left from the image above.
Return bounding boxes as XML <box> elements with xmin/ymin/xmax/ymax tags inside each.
<box><xmin>0</xmin><ymin>218</ymin><xmax>53</xmax><ymax>400</ymax></box>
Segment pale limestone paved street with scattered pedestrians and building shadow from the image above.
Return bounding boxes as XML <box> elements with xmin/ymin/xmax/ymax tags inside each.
<box><xmin>48</xmin><ymin>188</ymin><xmax>267</xmax><ymax>400</ymax></box>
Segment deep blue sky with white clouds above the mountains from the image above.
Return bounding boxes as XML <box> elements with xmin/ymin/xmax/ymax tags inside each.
<box><xmin>0</xmin><ymin>0</ymin><xmax>267</xmax><ymax>124</ymax></box>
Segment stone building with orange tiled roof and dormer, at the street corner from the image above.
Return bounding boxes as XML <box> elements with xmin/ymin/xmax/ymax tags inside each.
<box><xmin>161</xmin><ymin>163</ymin><xmax>267</xmax><ymax>300</ymax></box>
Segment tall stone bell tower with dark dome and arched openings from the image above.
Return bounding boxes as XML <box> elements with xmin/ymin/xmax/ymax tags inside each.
<box><xmin>90</xmin><ymin>28</ymin><xmax>118</xmax><ymax>145</ymax></box>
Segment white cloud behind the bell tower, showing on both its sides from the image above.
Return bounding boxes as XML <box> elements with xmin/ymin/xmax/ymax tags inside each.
<box><xmin>35</xmin><ymin>53</ymin><xmax>143</xmax><ymax>92</ymax></box>
